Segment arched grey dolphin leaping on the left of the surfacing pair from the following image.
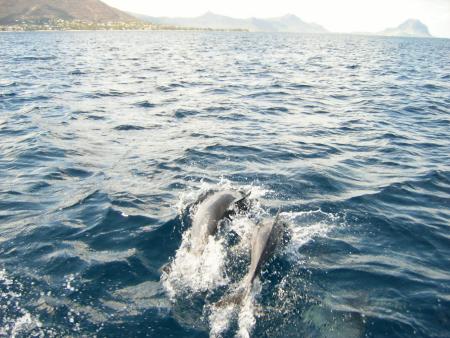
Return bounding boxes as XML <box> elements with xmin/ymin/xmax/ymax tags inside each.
<box><xmin>191</xmin><ymin>190</ymin><xmax>248</xmax><ymax>254</ymax></box>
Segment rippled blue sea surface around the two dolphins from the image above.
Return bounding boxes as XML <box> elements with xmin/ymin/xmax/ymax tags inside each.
<box><xmin>0</xmin><ymin>32</ymin><xmax>450</xmax><ymax>338</ymax></box>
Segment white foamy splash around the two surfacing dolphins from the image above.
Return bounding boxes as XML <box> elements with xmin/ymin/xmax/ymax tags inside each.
<box><xmin>165</xmin><ymin>184</ymin><xmax>342</xmax><ymax>337</ymax></box>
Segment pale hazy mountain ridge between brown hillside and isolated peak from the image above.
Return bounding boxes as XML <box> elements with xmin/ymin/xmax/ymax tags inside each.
<box><xmin>134</xmin><ymin>12</ymin><xmax>328</xmax><ymax>33</ymax></box>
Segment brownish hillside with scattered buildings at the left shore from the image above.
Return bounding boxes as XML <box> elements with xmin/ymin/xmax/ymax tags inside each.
<box><xmin>0</xmin><ymin>0</ymin><xmax>137</xmax><ymax>25</ymax></box>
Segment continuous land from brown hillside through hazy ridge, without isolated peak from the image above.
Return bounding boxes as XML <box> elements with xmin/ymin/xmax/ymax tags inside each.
<box><xmin>0</xmin><ymin>0</ymin><xmax>327</xmax><ymax>33</ymax></box>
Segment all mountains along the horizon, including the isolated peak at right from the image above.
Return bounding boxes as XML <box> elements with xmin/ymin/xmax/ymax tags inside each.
<box><xmin>0</xmin><ymin>0</ymin><xmax>431</xmax><ymax>37</ymax></box>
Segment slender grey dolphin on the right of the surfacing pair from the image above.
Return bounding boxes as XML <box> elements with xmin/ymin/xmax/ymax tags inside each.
<box><xmin>218</xmin><ymin>210</ymin><xmax>287</xmax><ymax>306</ymax></box>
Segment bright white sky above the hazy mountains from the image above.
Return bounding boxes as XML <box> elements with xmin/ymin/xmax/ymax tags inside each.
<box><xmin>103</xmin><ymin>0</ymin><xmax>450</xmax><ymax>38</ymax></box>
